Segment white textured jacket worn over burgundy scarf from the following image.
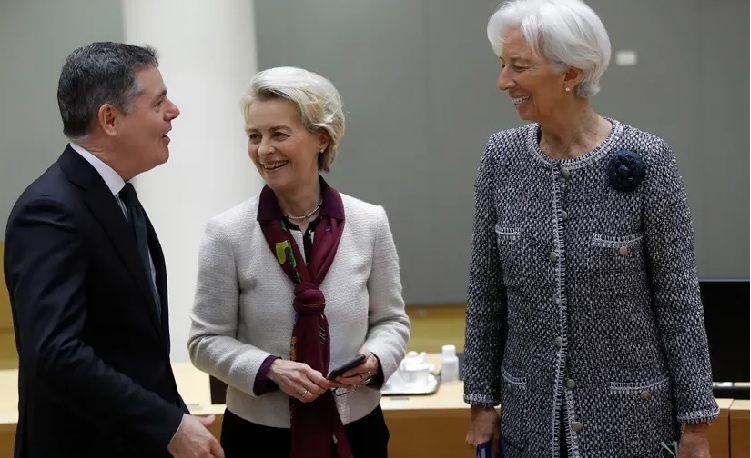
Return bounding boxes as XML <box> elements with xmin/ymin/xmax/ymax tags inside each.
<box><xmin>188</xmin><ymin>194</ymin><xmax>410</xmax><ymax>428</ymax></box>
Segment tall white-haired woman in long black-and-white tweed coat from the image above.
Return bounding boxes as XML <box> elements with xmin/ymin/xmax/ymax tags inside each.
<box><xmin>464</xmin><ymin>0</ymin><xmax>719</xmax><ymax>458</ymax></box>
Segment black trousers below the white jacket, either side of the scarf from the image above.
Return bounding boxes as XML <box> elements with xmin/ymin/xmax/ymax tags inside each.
<box><xmin>219</xmin><ymin>406</ymin><xmax>389</xmax><ymax>458</ymax></box>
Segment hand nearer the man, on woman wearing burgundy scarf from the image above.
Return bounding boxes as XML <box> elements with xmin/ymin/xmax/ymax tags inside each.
<box><xmin>268</xmin><ymin>359</ymin><xmax>331</xmax><ymax>402</ymax></box>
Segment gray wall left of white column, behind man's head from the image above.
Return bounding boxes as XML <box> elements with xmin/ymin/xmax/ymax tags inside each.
<box><xmin>0</xmin><ymin>0</ymin><xmax>124</xmax><ymax>229</ymax></box>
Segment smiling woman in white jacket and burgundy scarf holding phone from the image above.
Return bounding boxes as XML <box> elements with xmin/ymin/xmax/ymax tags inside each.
<box><xmin>188</xmin><ymin>67</ymin><xmax>409</xmax><ymax>458</ymax></box>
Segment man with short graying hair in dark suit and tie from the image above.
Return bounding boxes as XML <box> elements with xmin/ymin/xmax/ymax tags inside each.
<box><xmin>5</xmin><ymin>43</ymin><xmax>223</xmax><ymax>458</ymax></box>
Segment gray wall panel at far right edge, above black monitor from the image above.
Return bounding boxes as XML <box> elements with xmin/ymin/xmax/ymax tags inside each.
<box><xmin>687</xmin><ymin>0</ymin><xmax>749</xmax><ymax>278</ymax></box>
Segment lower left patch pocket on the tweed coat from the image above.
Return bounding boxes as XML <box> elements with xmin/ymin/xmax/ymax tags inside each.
<box><xmin>501</xmin><ymin>368</ymin><xmax>529</xmax><ymax>449</ymax></box>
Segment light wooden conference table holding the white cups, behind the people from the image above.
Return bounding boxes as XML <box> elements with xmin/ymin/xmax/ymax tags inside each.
<box><xmin>0</xmin><ymin>363</ymin><xmax>749</xmax><ymax>458</ymax></box>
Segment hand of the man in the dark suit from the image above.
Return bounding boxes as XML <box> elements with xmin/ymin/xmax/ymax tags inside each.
<box><xmin>167</xmin><ymin>414</ymin><xmax>224</xmax><ymax>458</ymax></box>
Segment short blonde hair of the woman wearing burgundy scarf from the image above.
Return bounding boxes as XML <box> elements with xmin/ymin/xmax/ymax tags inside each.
<box><xmin>241</xmin><ymin>67</ymin><xmax>344</xmax><ymax>172</ymax></box>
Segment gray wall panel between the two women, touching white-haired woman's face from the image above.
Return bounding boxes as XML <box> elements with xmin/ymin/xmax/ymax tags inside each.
<box><xmin>424</xmin><ymin>0</ymin><xmax>521</xmax><ymax>303</ymax></box>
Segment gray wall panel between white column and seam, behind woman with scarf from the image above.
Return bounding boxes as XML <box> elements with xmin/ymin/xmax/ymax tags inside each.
<box><xmin>256</xmin><ymin>0</ymin><xmax>438</xmax><ymax>300</ymax></box>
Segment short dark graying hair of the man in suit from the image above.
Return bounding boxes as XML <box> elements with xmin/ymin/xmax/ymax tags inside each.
<box><xmin>57</xmin><ymin>42</ymin><xmax>159</xmax><ymax>140</ymax></box>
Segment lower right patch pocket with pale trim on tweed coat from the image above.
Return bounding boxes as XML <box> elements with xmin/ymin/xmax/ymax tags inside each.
<box><xmin>610</xmin><ymin>376</ymin><xmax>678</xmax><ymax>457</ymax></box>
